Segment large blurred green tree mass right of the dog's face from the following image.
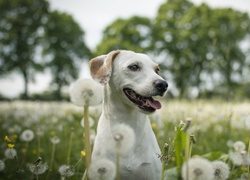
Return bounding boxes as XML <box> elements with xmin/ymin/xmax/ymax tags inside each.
<box><xmin>151</xmin><ymin>0</ymin><xmax>249</xmax><ymax>96</ymax></box>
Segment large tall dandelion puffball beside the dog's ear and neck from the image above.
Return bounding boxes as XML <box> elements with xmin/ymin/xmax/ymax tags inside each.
<box><xmin>70</xmin><ymin>79</ymin><xmax>103</xmax><ymax>107</ymax></box>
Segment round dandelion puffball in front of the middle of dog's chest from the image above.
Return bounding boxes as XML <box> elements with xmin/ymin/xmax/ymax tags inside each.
<box><xmin>108</xmin><ymin>124</ymin><xmax>135</xmax><ymax>154</ymax></box>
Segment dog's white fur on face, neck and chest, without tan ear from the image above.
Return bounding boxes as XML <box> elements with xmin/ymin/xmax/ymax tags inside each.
<box><xmin>90</xmin><ymin>50</ymin><xmax>166</xmax><ymax>180</ymax></box>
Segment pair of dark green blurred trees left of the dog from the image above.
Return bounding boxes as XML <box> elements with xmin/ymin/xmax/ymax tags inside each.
<box><xmin>0</xmin><ymin>0</ymin><xmax>90</xmax><ymax>99</ymax></box>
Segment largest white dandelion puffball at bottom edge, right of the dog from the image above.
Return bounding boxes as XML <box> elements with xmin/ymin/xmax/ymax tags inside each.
<box><xmin>181</xmin><ymin>158</ymin><xmax>214</xmax><ymax>180</ymax></box>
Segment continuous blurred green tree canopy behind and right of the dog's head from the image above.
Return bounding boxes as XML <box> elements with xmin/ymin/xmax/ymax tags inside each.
<box><xmin>96</xmin><ymin>0</ymin><xmax>250</xmax><ymax>97</ymax></box>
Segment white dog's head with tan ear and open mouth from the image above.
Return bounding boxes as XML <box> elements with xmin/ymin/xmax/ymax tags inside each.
<box><xmin>89</xmin><ymin>50</ymin><xmax>168</xmax><ymax>113</ymax></box>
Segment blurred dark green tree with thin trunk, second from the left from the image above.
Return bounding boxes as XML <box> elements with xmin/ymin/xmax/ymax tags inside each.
<box><xmin>43</xmin><ymin>11</ymin><xmax>90</xmax><ymax>100</ymax></box>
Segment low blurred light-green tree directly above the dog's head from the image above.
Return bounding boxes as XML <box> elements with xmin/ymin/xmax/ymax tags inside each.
<box><xmin>95</xmin><ymin>16</ymin><xmax>151</xmax><ymax>55</ymax></box>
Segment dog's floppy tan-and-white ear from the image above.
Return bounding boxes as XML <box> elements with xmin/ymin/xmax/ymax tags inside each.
<box><xmin>89</xmin><ymin>51</ymin><xmax>120</xmax><ymax>85</ymax></box>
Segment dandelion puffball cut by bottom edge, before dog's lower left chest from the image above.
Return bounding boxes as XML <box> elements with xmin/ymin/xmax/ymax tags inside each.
<box><xmin>88</xmin><ymin>159</ymin><xmax>116</xmax><ymax>180</ymax></box>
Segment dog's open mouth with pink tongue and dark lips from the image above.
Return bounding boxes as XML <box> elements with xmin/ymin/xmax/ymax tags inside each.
<box><xmin>123</xmin><ymin>88</ymin><xmax>161</xmax><ymax>112</ymax></box>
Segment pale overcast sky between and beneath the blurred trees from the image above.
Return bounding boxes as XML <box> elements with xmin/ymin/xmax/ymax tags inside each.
<box><xmin>0</xmin><ymin>0</ymin><xmax>250</xmax><ymax>97</ymax></box>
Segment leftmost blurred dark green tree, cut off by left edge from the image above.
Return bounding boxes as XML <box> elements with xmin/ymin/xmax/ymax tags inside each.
<box><xmin>0</xmin><ymin>0</ymin><xmax>48</xmax><ymax>99</ymax></box>
